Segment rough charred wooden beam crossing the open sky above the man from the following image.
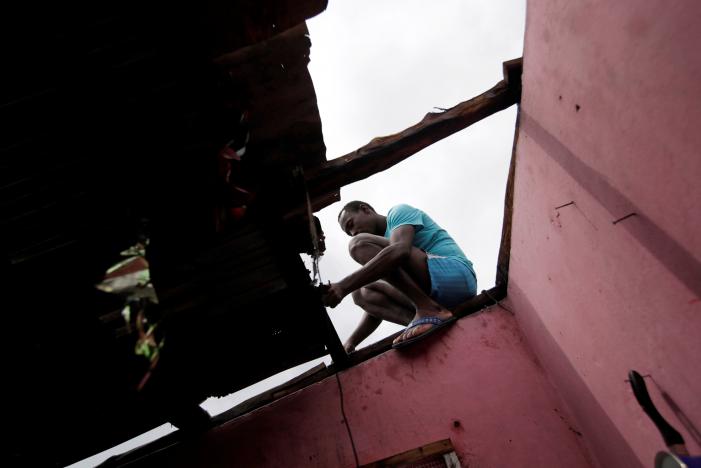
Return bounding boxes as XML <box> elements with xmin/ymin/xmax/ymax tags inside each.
<box><xmin>307</xmin><ymin>59</ymin><xmax>522</xmax><ymax>197</ymax></box>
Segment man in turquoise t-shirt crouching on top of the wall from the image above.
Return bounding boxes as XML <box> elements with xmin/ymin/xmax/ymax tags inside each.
<box><xmin>323</xmin><ymin>201</ymin><xmax>477</xmax><ymax>352</ymax></box>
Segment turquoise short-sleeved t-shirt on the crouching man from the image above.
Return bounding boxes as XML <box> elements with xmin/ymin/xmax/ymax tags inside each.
<box><xmin>385</xmin><ymin>204</ymin><xmax>475</xmax><ymax>274</ymax></box>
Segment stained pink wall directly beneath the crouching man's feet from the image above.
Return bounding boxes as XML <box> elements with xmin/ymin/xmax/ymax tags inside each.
<box><xmin>139</xmin><ymin>308</ymin><xmax>591</xmax><ymax>468</ymax></box>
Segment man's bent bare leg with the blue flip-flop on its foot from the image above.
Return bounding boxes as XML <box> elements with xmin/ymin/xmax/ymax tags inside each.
<box><xmin>349</xmin><ymin>234</ymin><xmax>453</xmax><ymax>343</ymax></box>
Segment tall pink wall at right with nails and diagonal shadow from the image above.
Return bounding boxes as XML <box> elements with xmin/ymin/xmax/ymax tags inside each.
<box><xmin>508</xmin><ymin>0</ymin><xmax>701</xmax><ymax>467</ymax></box>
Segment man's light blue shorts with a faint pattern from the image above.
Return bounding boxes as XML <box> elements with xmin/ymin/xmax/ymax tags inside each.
<box><xmin>427</xmin><ymin>254</ymin><xmax>477</xmax><ymax>309</ymax></box>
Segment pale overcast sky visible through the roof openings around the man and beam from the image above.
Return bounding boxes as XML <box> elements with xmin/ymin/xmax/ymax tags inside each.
<box><xmin>69</xmin><ymin>0</ymin><xmax>526</xmax><ymax>467</ymax></box>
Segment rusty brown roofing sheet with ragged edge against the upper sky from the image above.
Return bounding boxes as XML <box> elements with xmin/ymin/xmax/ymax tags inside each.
<box><xmin>214</xmin><ymin>22</ymin><xmax>326</xmax><ymax>172</ymax></box>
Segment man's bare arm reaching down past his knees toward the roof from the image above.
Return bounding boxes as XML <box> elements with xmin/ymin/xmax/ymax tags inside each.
<box><xmin>324</xmin><ymin>224</ymin><xmax>414</xmax><ymax>307</ymax></box>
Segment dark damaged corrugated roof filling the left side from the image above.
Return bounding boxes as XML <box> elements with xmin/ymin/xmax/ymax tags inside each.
<box><xmin>0</xmin><ymin>0</ymin><xmax>345</xmax><ymax>466</ymax></box>
